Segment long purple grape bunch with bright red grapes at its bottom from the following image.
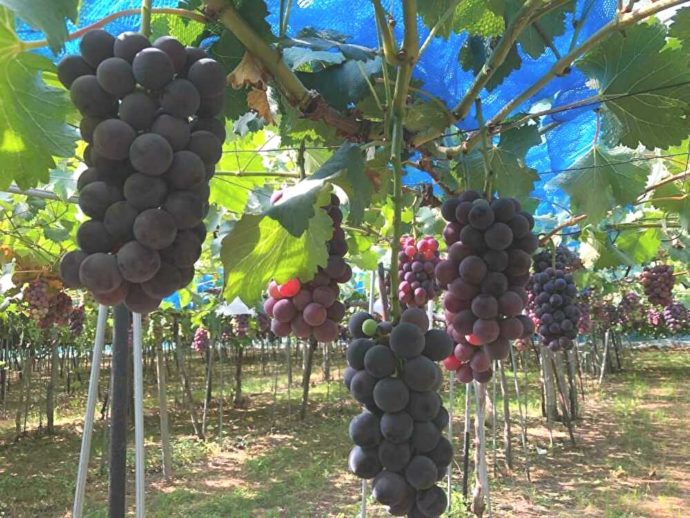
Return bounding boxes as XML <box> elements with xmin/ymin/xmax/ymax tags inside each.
<box><xmin>436</xmin><ymin>191</ymin><xmax>539</xmax><ymax>383</ymax></box>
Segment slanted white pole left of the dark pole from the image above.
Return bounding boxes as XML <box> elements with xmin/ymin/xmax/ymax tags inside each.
<box><xmin>72</xmin><ymin>304</ymin><xmax>108</xmax><ymax>518</ymax></box>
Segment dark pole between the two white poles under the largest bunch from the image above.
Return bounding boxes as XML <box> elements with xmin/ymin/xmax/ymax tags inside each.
<box><xmin>108</xmin><ymin>304</ymin><xmax>129</xmax><ymax>518</ymax></box>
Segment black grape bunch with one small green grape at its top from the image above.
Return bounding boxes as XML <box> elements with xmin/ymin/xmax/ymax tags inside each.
<box><xmin>344</xmin><ymin>308</ymin><xmax>453</xmax><ymax>517</ymax></box>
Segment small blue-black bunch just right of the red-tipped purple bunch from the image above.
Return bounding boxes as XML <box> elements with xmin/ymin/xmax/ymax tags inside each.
<box><xmin>531</xmin><ymin>267</ymin><xmax>581</xmax><ymax>351</ymax></box>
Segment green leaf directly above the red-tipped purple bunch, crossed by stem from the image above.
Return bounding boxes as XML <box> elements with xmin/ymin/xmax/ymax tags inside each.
<box><xmin>456</xmin><ymin>125</ymin><xmax>541</xmax><ymax>199</ymax></box>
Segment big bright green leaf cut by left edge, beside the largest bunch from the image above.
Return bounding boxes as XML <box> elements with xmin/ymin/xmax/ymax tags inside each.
<box><xmin>0</xmin><ymin>18</ymin><xmax>77</xmax><ymax>189</ymax></box>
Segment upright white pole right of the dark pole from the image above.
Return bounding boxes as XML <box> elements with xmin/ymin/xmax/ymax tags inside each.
<box><xmin>132</xmin><ymin>313</ymin><xmax>146</xmax><ymax>518</ymax></box>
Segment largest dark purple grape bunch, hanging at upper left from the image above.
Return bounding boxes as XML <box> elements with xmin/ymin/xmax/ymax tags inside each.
<box><xmin>58</xmin><ymin>30</ymin><xmax>226</xmax><ymax>313</ymax></box>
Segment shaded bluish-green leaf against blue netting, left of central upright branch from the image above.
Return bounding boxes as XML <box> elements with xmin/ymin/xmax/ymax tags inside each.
<box><xmin>297</xmin><ymin>58</ymin><xmax>381</xmax><ymax>110</ymax></box>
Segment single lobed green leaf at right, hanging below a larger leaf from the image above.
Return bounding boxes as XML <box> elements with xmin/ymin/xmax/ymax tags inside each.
<box><xmin>555</xmin><ymin>146</ymin><xmax>649</xmax><ymax>222</ymax></box>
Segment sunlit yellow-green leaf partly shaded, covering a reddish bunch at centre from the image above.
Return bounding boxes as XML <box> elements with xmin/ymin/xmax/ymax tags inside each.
<box><xmin>221</xmin><ymin>207</ymin><xmax>333</xmax><ymax>305</ymax></box>
